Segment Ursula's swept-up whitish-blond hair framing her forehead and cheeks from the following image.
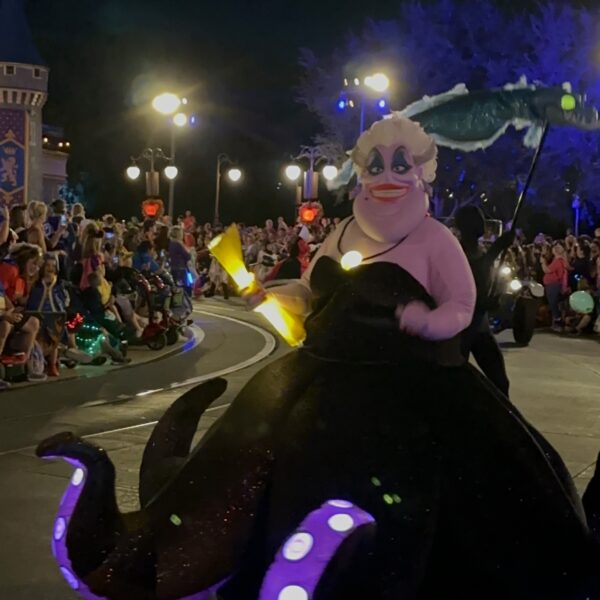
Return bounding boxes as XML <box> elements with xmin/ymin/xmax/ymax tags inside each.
<box><xmin>351</xmin><ymin>115</ymin><xmax>437</xmax><ymax>183</ymax></box>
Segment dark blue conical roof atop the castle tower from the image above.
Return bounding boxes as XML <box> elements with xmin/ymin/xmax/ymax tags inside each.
<box><xmin>0</xmin><ymin>0</ymin><xmax>44</xmax><ymax>65</ymax></box>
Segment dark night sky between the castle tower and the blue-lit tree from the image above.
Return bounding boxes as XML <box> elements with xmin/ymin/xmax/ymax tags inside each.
<box><xmin>22</xmin><ymin>0</ymin><xmax>596</xmax><ymax>221</ymax></box>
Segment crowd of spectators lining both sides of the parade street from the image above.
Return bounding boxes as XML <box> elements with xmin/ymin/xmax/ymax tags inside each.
<box><xmin>0</xmin><ymin>200</ymin><xmax>600</xmax><ymax>388</ymax></box>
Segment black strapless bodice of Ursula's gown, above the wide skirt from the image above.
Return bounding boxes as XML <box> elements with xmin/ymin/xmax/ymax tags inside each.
<box><xmin>304</xmin><ymin>256</ymin><xmax>463</xmax><ymax>365</ymax></box>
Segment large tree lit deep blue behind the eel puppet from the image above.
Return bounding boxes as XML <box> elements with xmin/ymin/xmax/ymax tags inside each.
<box><xmin>298</xmin><ymin>0</ymin><xmax>600</xmax><ymax>225</ymax></box>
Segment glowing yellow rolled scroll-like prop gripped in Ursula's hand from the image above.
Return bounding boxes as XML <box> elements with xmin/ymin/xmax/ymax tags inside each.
<box><xmin>208</xmin><ymin>225</ymin><xmax>306</xmax><ymax>347</ymax></box>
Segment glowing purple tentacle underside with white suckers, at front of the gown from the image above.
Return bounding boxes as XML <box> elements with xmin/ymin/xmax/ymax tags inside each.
<box><xmin>259</xmin><ymin>500</ymin><xmax>375</xmax><ymax>600</ymax></box>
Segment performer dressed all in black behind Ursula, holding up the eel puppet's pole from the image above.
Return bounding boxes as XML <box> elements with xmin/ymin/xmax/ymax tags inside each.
<box><xmin>454</xmin><ymin>206</ymin><xmax>515</xmax><ymax>396</ymax></box>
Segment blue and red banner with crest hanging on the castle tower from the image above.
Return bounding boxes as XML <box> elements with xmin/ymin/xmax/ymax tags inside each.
<box><xmin>0</xmin><ymin>109</ymin><xmax>27</xmax><ymax>204</ymax></box>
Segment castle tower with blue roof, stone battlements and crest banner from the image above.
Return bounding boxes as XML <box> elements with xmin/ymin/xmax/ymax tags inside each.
<box><xmin>0</xmin><ymin>0</ymin><xmax>48</xmax><ymax>204</ymax></box>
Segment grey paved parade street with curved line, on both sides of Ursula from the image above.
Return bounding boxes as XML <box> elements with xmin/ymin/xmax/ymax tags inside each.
<box><xmin>0</xmin><ymin>299</ymin><xmax>600</xmax><ymax>600</ymax></box>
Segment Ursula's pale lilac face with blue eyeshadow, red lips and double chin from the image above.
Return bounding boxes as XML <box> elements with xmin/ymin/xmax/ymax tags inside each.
<box><xmin>353</xmin><ymin>146</ymin><xmax>429</xmax><ymax>242</ymax></box>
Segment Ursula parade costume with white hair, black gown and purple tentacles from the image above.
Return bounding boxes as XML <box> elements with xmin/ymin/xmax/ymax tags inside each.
<box><xmin>38</xmin><ymin>117</ymin><xmax>600</xmax><ymax>600</ymax></box>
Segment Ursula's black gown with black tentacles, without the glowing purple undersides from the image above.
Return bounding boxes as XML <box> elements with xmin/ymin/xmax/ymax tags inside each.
<box><xmin>38</xmin><ymin>257</ymin><xmax>600</xmax><ymax>600</ymax></box>
